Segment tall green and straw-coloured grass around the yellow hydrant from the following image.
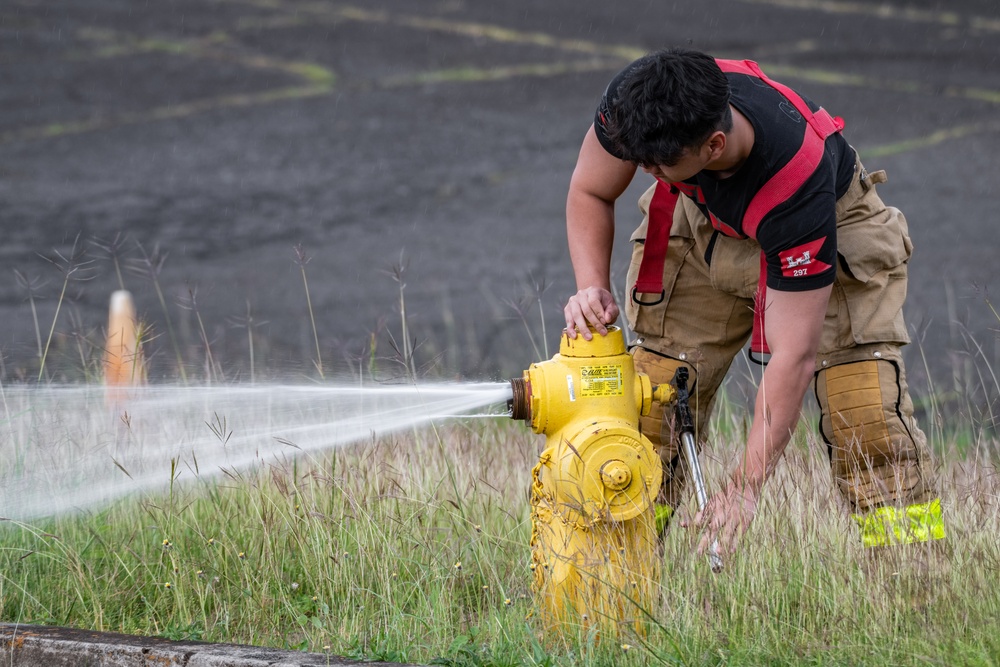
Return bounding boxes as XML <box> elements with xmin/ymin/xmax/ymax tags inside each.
<box><xmin>0</xmin><ymin>235</ymin><xmax>1000</xmax><ymax>666</ymax></box>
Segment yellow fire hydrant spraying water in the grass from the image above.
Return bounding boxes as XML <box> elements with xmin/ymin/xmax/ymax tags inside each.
<box><xmin>511</xmin><ymin>327</ymin><xmax>675</xmax><ymax>628</ymax></box>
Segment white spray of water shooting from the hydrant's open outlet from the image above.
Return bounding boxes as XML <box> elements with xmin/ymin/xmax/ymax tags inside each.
<box><xmin>0</xmin><ymin>383</ymin><xmax>510</xmax><ymax>520</ymax></box>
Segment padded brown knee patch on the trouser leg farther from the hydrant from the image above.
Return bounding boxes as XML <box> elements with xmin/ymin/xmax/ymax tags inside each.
<box><xmin>816</xmin><ymin>359</ymin><xmax>926</xmax><ymax>512</ymax></box>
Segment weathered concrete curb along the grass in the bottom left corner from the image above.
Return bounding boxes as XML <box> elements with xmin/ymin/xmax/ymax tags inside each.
<box><xmin>0</xmin><ymin>623</ymin><xmax>414</xmax><ymax>667</ymax></box>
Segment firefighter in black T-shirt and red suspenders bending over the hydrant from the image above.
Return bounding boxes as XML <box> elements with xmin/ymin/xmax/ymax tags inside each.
<box><xmin>564</xmin><ymin>49</ymin><xmax>944</xmax><ymax>552</ymax></box>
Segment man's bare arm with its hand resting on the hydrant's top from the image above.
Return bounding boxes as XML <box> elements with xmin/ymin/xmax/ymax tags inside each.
<box><xmin>563</xmin><ymin>127</ymin><xmax>636</xmax><ymax>340</ymax></box>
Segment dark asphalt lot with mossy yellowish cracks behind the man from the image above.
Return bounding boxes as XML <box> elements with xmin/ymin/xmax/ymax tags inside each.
<box><xmin>0</xmin><ymin>0</ymin><xmax>1000</xmax><ymax>392</ymax></box>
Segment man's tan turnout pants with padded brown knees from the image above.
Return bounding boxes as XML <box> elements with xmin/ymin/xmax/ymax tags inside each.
<box><xmin>625</xmin><ymin>163</ymin><xmax>940</xmax><ymax>514</ymax></box>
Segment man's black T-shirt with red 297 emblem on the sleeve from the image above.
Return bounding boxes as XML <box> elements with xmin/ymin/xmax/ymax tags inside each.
<box><xmin>594</xmin><ymin>70</ymin><xmax>855</xmax><ymax>292</ymax></box>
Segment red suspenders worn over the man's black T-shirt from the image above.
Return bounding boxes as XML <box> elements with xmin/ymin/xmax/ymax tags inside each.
<box><xmin>632</xmin><ymin>60</ymin><xmax>844</xmax><ymax>354</ymax></box>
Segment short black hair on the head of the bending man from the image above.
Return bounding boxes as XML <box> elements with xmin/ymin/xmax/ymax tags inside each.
<box><xmin>601</xmin><ymin>49</ymin><xmax>733</xmax><ymax>166</ymax></box>
